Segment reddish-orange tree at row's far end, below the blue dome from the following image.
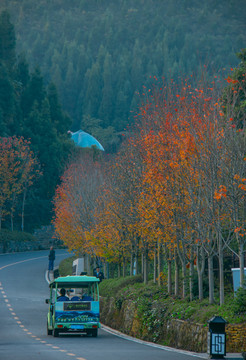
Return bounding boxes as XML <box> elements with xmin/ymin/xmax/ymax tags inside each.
<box><xmin>53</xmin><ymin>154</ymin><xmax>103</xmax><ymax>255</ymax></box>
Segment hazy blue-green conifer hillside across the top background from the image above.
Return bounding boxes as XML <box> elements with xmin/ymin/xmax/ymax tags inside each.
<box><xmin>0</xmin><ymin>0</ymin><xmax>246</xmax><ymax>151</ymax></box>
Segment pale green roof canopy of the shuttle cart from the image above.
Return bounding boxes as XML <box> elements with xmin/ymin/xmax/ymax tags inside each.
<box><xmin>50</xmin><ymin>275</ymin><xmax>99</xmax><ymax>288</ymax></box>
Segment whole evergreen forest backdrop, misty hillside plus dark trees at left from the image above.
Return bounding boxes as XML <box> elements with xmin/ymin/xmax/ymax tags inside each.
<box><xmin>0</xmin><ymin>0</ymin><xmax>246</xmax><ymax>230</ymax></box>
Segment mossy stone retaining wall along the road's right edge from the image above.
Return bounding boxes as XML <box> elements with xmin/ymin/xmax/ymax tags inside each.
<box><xmin>100</xmin><ymin>298</ymin><xmax>246</xmax><ymax>353</ymax></box>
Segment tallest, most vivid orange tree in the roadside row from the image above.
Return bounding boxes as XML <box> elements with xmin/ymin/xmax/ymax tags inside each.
<box><xmin>135</xmin><ymin>81</ymin><xmax>213</xmax><ymax>296</ymax></box>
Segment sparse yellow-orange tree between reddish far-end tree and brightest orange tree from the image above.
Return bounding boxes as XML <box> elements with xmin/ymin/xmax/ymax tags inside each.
<box><xmin>97</xmin><ymin>137</ymin><xmax>145</xmax><ymax>274</ymax></box>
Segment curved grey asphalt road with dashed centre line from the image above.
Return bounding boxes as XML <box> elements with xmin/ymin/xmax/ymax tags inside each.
<box><xmin>0</xmin><ymin>250</ymin><xmax>207</xmax><ymax>360</ymax></box>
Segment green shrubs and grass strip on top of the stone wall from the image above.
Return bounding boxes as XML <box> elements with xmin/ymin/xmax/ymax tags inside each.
<box><xmin>100</xmin><ymin>276</ymin><xmax>246</xmax><ymax>325</ymax></box>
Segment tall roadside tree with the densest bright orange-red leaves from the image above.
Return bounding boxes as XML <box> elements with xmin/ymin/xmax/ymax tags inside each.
<box><xmin>136</xmin><ymin>88</ymin><xmax>202</xmax><ymax>296</ymax></box>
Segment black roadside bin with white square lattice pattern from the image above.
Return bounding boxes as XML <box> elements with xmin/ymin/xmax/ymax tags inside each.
<box><xmin>208</xmin><ymin>316</ymin><xmax>227</xmax><ymax>359</ymax></box>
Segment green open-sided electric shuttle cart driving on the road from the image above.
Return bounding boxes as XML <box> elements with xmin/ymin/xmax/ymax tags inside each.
<box><xmin>46</xmin><ymin>275</ymin><xmax>100</xmax><ymax>337</ymax></box>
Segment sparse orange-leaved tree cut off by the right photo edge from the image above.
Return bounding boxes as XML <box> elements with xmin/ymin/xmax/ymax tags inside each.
<box><xmin>214</xmin><ymin>100</ymin><xmax>246</xmax><ymax>287</ymax></box>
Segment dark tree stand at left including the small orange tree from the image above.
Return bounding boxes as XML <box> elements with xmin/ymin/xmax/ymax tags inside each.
<box><xmin>0</xmin><ymin>11</ymin><xmax>74</xmax><ymax>230</ymax></box>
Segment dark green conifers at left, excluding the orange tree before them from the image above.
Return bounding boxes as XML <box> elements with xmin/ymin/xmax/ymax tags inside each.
<box><xmin>0</xmin><ymin>11</ymin><xmax>74</xmax><ymax>230</ymax></box>
